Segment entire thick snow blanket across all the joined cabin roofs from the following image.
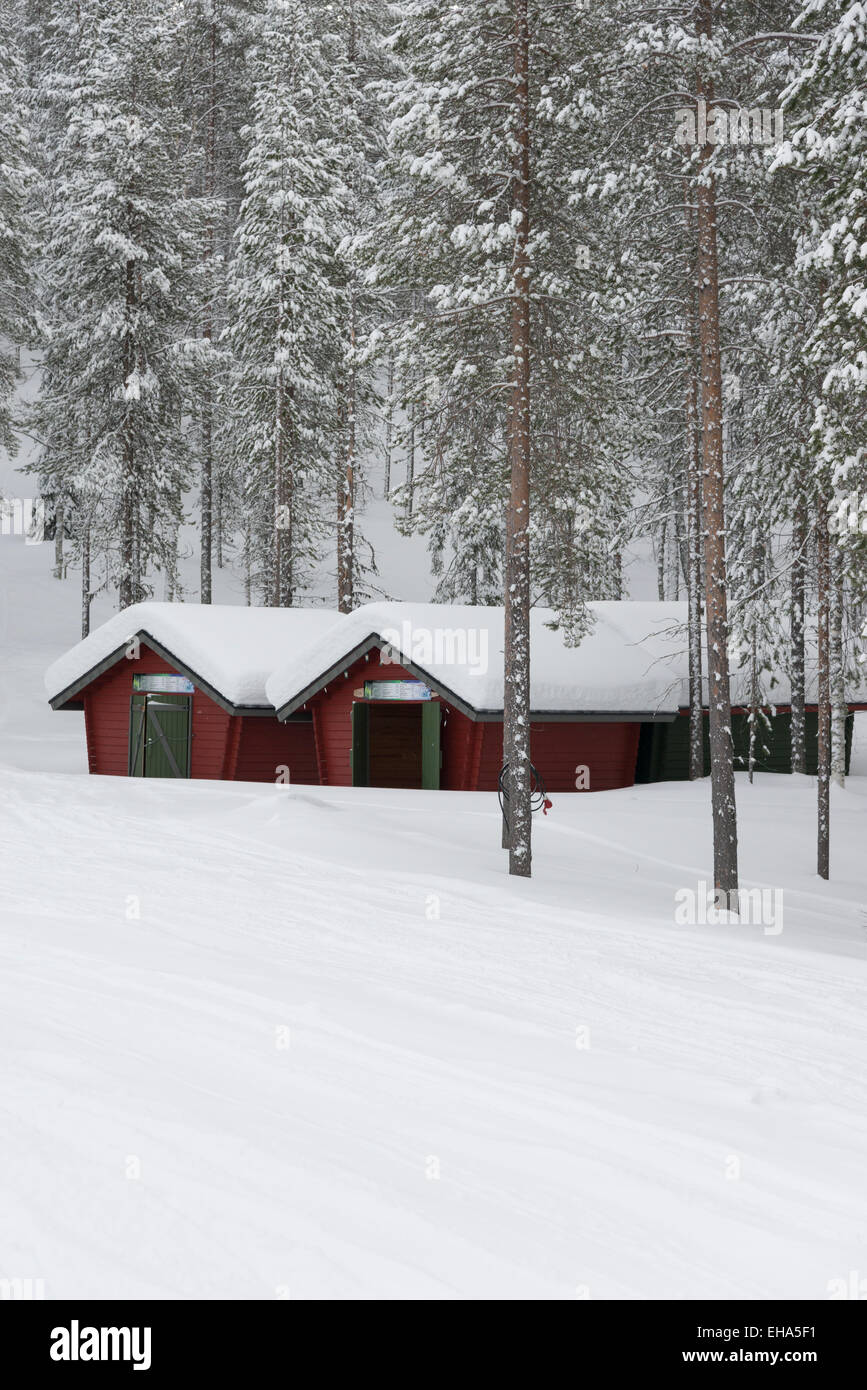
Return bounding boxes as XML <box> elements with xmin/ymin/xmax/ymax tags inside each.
<box><xmin>46</xmin><ymin>600</ymin><xmax>867</xmax><ymax>719</ymax></box>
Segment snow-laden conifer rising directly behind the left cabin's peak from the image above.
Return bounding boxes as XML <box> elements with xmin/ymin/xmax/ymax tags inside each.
<box><xmin>35</xmin><ymin>0</ymin><xmax>193</xmax><ymax>606</ymax></box>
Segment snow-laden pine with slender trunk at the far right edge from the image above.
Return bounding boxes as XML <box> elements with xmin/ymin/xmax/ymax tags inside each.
<box><xmin>777</xmin><ymin>0</ymin><xmax>867</xmax><ymax>878</ymax></box>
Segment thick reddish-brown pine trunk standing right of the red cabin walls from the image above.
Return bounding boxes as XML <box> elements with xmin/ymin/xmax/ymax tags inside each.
<box><xmin>697</xmin><ymin>0</ymin><xmax>738</xmax><ymax>909</ymax></box>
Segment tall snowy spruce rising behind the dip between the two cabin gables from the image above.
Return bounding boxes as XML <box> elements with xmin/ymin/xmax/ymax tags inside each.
<box><xmin>222</xmin><ymin>0</ymin><xmax>345</xmax><ymax>606</ymax></box>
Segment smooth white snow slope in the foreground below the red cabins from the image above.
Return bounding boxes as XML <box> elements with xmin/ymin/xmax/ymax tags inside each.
<box><xmin>0</xmin><ymin>761</ymin><xmax>867</xmax><ymax>1298</ymax></box>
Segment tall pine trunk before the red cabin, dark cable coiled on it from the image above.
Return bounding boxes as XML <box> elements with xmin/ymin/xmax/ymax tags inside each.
<box><xmin>503</xmin><ymin>0</ymin><xmax>532</xmax><ymax>877</ymax></box>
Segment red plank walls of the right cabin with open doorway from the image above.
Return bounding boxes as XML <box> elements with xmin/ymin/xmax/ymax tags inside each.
<box><xmin>301</xmin><ymin>652</ymin><xmax>641</xmax><ymax>792</ymax></box>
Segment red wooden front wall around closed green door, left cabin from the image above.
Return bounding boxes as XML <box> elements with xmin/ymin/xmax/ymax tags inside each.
<box><xmin>83</xmin><ymin>644</ymin><xmax>232</xmax><ymax>778</ymax></box>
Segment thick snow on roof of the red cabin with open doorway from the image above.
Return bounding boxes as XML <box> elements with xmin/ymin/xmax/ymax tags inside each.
<box><xmin>265</xmin><ymin>602</ymin><xmax>686</xmax><ymax>717</ymax></box>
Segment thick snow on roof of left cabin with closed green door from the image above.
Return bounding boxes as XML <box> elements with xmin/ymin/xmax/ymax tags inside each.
<box><xmin>44</xmin><ymin>603</ymin><xmax>340</xmax><ymax>708</ymax></box>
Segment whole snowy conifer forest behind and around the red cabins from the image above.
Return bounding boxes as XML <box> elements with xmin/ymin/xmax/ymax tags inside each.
<box><xmin>0</xmin><ymin>0</ymin><xmax>867</xmax><ymax>891</ymax></box>
